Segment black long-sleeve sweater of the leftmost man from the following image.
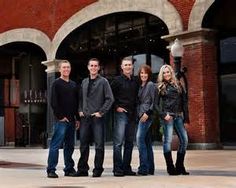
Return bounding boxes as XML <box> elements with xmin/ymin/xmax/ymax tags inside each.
<box><xmin>50</xmin><ymin>78</ymin><xmax>79</xmax><ymax>121</ymax></box>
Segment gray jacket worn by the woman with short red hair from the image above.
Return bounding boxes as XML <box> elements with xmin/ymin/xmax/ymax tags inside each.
<box><xmin>137</xmin><ymin>81</ymin><xmax>156</xmax><ymax>118</ymax></box>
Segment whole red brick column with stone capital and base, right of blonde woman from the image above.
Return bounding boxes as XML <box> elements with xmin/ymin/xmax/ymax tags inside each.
<box><xmin>163</xmin><ymin>29</ymin><xmax>220</xmax><ymax>149</ymax></box>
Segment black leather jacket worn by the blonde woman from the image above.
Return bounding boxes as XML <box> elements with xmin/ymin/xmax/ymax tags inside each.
<box><xmin>156</xmin><ymin>83</ymin><xmax>189</xmax><ymax>123</ymax></box>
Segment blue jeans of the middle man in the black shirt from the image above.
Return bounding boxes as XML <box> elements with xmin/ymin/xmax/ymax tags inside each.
<box><xmin>113</xmin><ymin>112</ymin><xmax>135</xmax><ymax>172</ymax></box>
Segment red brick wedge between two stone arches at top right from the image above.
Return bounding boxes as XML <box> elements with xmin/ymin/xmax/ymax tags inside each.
<box><xmin>169</xmin><ymin>0</ymin><xmax>195</xmax><ymax>30</ymax></box>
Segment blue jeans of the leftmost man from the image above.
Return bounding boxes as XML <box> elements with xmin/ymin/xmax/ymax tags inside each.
<box><xmin>47</xmin><ymin>121</ymin><xmax>75</xmax><ymax>173</ymax></box>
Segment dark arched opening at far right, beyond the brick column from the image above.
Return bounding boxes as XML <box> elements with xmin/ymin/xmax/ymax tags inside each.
<box><xmin>202</xmin><ymin>0</ymin><xmax>236</xmax><ymax>144</ymax></box>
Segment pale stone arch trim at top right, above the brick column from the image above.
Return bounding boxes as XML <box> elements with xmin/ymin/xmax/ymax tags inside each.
<box><xmin>188</xmin><ymin>0</ymin><xmax>215</xmax><ymax>31</ymax></box>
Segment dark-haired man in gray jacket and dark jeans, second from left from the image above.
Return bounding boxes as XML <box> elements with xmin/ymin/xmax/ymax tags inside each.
<box><xmin>76</xmin><ymin>58</ymin><xmax>114</xmax><ymax>177</ymax></box>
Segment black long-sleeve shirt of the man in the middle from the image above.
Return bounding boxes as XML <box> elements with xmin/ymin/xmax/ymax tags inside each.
<box><xmin>111</xmin><ymin>74</ymin><xmax>139</xmax><ymax>114</ymax></box>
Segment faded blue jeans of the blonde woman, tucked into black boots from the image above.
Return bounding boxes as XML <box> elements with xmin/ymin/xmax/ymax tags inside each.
<box><xmin>163</xmin><ymin>116</ymin><xmax>188</xmax><ymax>153</ymax></box>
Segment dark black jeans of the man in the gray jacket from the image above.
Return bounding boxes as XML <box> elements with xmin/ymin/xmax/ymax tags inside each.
<box><xmin>78</xmin><ymin>117</ymin><xmax>105</xmax><ymax>173</ymax></box>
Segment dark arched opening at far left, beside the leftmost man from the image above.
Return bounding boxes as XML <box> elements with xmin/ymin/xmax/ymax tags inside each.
<box><xmin>0</xmin><ymin>42</ymin><xmax>47</xmax><ymax>146</ymax></box>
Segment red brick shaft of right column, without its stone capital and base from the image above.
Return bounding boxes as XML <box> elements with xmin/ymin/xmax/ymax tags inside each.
<box><xmin>183</xmin><ymin>43</ymin><xmax>219</xmax><ymax>143</ymax></box>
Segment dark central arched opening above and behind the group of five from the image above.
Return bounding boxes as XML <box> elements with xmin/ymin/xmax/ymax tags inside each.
<box><xmin>56</xmin><ymin>12</ymin><xmax>169</xmax><ymax>140</ymax></box>
